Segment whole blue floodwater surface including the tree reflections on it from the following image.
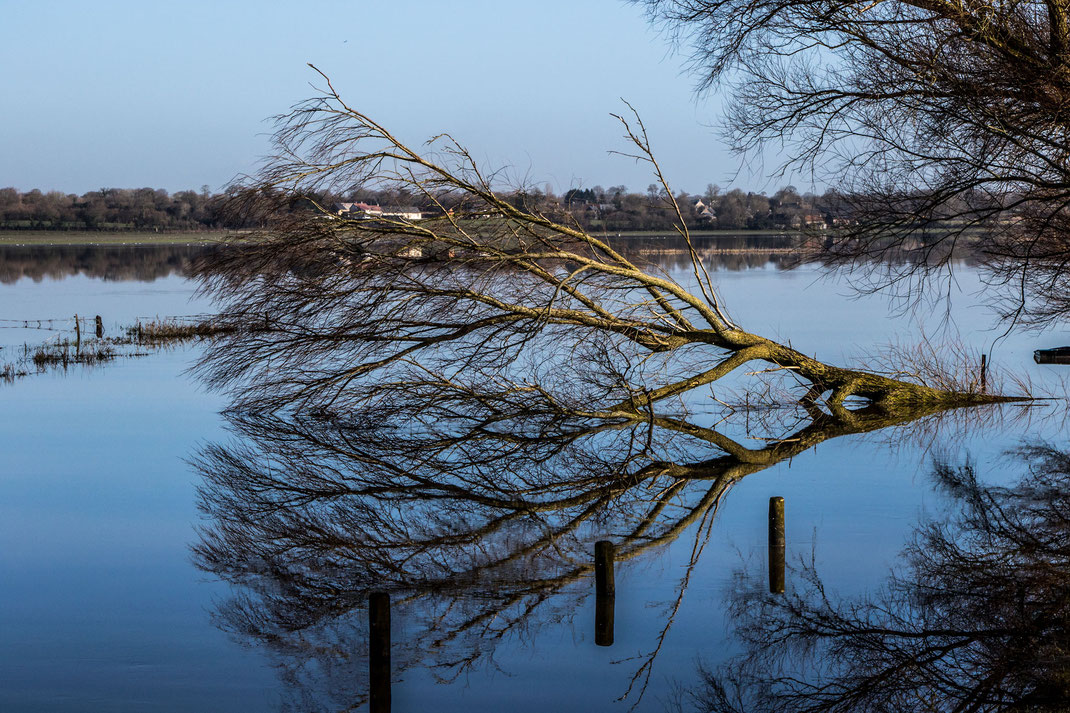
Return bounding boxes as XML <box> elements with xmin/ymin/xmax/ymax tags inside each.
<box><xmin>0</xmin><ymin>245</ymin><xmax>1070</xmax><ymax>712</ymax></box>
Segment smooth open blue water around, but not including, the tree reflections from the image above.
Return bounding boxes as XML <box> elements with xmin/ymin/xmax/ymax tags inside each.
<box><xmin>0</xmin><ymin>243</ymin><xmax>1070</xmax><ymax>712</ymax></box>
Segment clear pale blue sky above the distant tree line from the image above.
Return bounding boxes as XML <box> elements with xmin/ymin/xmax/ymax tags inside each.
<box><xmin>0</xmin><ymin>0</ymin><xmax>787</xmax><ymax>193</ymax></box>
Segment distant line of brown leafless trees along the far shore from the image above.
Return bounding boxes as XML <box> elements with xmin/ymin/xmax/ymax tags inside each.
<box><xmin>0</xmin><ymin>185</ymin><xmax>844</xmax><ymax>232</ymax></box>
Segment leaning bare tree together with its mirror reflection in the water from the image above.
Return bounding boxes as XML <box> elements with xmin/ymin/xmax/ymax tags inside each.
<box><xmin>186</xmin><ymin>72</ymin><xmax>1044</xmax><ymax>703</ymax></box>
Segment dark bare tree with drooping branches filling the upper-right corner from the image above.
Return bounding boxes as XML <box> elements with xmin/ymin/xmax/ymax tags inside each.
<box><xmin>637</xmin><ymin>0</ymin><xmax>1070</xmax><ymax>323</ymax></box>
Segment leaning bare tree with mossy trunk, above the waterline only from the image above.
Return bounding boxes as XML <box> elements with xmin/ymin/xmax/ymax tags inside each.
<box><xmin>194</xmin><ymin>67</ymin><xmax>1004</xmax><ymax>421</ymax></box>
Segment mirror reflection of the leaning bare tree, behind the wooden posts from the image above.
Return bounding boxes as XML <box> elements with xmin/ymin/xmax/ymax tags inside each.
<box><xmin>188</xmin><ymin>379</ymin><xmax>975</xmax><ymax>710</ymax></box>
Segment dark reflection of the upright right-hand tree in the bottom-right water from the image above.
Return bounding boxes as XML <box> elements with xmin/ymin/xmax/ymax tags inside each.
<box><xmin>686</xmin><ymin>445</ymin><xmax>1070</xmax><ymax>713</ymax></box>
